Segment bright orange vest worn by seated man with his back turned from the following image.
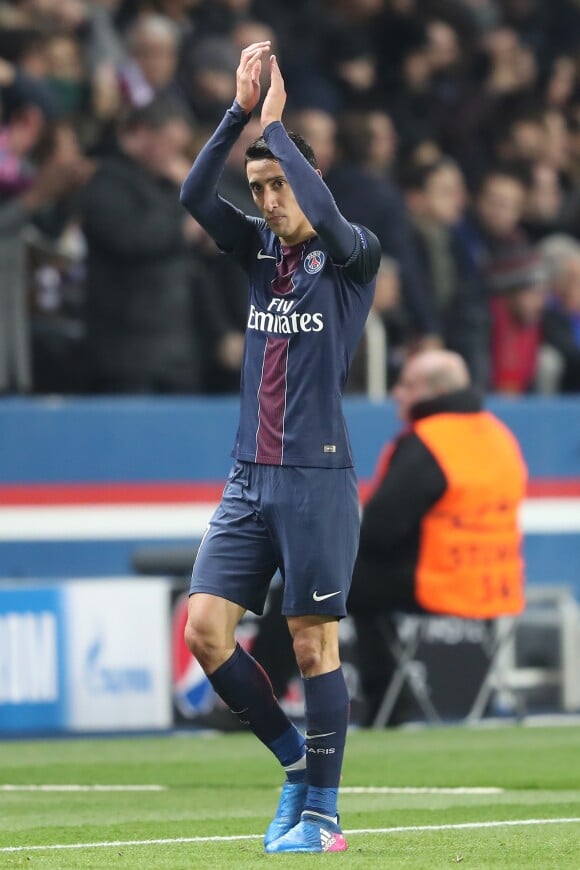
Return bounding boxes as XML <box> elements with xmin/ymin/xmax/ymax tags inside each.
<box><xmin>413</xmin><ymin>411</ymin><xmax>527</xmax><ymax>618</ymax></box>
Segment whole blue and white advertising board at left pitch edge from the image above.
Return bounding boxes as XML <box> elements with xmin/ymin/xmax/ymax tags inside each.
<box><xmin>0</xmin><ymin>578</ymin><xmax>172</xmax><ymax>734</ymax></box>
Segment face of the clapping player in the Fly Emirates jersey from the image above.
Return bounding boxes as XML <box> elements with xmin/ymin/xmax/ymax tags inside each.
<box><xmin>246</xmin><ymin>160</ymin><xmax>313</xmax><ymax>245</ymax></box>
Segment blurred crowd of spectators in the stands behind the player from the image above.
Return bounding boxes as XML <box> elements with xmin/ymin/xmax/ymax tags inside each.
<box><xmin>0</xmin><ymin>0</ymin><xmax>580</xmax><ymax>394</ymax></box>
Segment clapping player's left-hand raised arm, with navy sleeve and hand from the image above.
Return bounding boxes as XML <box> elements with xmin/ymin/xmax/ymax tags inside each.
<box><xmin>180</xmin><ymin>42</ymin><xmax>270</xmax><ymax>251</ymax></box>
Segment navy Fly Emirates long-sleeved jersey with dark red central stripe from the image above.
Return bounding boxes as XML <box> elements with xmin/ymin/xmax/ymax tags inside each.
<box><xmin>181</xmin><ymin>103</ymin><xmax>380</xmax><ymax>468</ymax></box>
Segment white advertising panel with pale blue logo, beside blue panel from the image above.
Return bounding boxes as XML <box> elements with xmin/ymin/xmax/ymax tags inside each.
<box><xmin>66</xmin><ymin>579</ymin><xmax>172</xmax><ymax>731</ymax></box>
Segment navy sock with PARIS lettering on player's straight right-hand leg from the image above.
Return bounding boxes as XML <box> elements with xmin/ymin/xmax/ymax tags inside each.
<box><xmin>303</xmin><ymin>668</ymin><xmax>349</xmax><ymax>817</ymax></box>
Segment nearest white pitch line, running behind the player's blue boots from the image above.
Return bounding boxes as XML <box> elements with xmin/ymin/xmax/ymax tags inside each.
<box><xmin>0</xmin><ymin>817</ymin><xmax>580</xmax><ymax>853</ymax></box>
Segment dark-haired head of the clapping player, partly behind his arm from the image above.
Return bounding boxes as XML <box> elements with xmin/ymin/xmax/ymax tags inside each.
<box><xmin>245</xmin><ymin>133</ymin><xmax>319</xmax><ymax>245</ymax></box>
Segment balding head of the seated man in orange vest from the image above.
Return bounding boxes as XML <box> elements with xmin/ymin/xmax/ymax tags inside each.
<box><xmin>393</xmin><ymin>350</ymin><xmax>469</xmax><ymax>421</ymax></box>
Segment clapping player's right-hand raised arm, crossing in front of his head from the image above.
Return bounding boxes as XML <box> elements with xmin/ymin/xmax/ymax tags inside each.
<box><xmin>261</xmin><ymin>55</ymin><xmax>357</xmax><ymax>263</ymax></box>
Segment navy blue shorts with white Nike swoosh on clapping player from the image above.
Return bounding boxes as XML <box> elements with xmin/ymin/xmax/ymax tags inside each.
<box><xmin>190</xmin><ymin>461</ymin><xmax>360</xmax><ymax>617</ymax></box>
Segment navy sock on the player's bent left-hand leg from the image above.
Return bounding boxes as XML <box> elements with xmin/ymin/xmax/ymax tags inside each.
<box><xmin>209</xmin><ymin>644</ymin><xmax>304</xmax><ymax>767</ymax></box>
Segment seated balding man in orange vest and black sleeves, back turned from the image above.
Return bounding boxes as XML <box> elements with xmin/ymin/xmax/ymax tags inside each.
<box><xmin>348</xmin><ymin>350</ymin><xmax>527</xmax><ymax>719</ymax></box>
